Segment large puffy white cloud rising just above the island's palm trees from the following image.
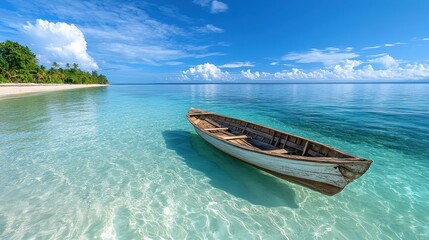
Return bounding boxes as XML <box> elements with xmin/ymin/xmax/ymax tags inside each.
<box><xmin>23</xmin><ymin>19</ymin><xmax>98</xmax><ymax>70</ymax></box>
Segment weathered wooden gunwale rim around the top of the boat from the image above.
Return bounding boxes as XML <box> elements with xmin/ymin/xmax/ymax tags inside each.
<box><xmin>186</xmin><ymin>108</ymin><xmax>372</xmax><ymax>165</ymax></box>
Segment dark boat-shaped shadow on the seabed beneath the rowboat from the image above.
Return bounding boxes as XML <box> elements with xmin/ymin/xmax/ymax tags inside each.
<box><xmin>162</xmin><ymin>131</ymin><xmax>298</xmax><ymax>208</ymax></box>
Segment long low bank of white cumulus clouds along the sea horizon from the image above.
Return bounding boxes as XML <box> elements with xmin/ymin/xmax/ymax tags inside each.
<box><xmin>182</xmin><ymin>54</ymin><xmax>429</xmax><ymax>81</ymax></box>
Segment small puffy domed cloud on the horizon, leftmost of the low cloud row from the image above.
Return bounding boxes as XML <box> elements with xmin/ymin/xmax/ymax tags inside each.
<box><xmin>182</xmin><ymin>63</ymin><xmax>230</xmax><ymax>80</ymax></box>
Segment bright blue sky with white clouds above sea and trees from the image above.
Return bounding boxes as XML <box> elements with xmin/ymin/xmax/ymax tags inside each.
<box><xmin>0</xmin><ymin>0</ymin><xmax>429</xmax><ymax>83</ymax></box>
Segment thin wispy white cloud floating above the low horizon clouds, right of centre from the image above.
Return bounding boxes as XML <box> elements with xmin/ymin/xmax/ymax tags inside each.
<box><xmin>282</xmin><ymin>48</ymin><xmax>359</xmax><ymax>65</ymax></box>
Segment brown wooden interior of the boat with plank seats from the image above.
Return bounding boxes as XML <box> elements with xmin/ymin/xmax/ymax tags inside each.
<box><xmin>188</xmin><ymin>113</ymin><xmax>355</xmax><ymax>158</ymax></box>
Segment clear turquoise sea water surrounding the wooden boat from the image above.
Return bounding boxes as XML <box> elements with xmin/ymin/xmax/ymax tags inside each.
<box><xmin>0</xmin><ymin>84</ymin><xmax>429</xmax><ymax>239</ymax></box>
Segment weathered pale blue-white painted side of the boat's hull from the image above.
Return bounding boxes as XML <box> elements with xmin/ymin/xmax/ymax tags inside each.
<box><xmin>195</xmin><ymin>128</ymin><xmax>349</xmax><ymax>195</ymax></box>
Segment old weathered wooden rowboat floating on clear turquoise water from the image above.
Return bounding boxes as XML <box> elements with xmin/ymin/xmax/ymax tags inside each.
<box><xmin>186</xmin><ymin>108</ymin><xmax>372</xmax><ymax>196</ymax></box>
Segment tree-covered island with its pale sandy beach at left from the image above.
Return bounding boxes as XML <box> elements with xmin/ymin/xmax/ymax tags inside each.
<box><xmin>0</xmin><ymin>40</ymin><xmax>109</xmax><ymax>97</ymax></box>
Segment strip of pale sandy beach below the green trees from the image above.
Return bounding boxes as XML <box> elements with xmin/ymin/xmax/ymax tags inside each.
<box><xmin>0</xmin><ymin>83</ymin><xmax>109</xmax><ymax>100</ymax></box>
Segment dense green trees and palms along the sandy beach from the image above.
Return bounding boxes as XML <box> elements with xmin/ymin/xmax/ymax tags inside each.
<box><xmin>0</xmin><ymin>41</ymin><xmax>109</xmax><ymax>84</ymax></box>
